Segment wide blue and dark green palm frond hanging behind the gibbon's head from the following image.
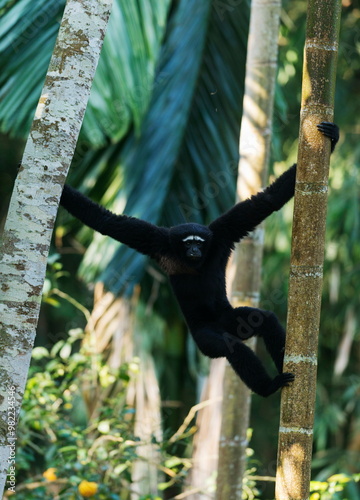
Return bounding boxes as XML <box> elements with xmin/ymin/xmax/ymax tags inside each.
<box><xmin>82</xmin><ymin>1</ymin><xmax>249</xmax><ymax>293</ymax></box>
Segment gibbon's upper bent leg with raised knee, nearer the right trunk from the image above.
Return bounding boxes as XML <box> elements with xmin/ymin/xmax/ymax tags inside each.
<box><xmin>231</xmin><ymin>307</ymin><xmax>285</xmax><ymax>373</ymax></box>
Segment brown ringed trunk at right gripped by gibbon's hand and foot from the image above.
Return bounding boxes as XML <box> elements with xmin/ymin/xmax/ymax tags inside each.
<box><xmin>276</xmin><ymin>0</ymin><xmax>341</xmax><ymax>500</ymax></box>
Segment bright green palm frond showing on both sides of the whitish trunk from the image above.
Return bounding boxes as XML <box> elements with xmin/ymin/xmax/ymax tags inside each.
<box><xmin>0</xmin><ymin>0</ymin><xmax>170</xmax><ymax>144</ymax></box>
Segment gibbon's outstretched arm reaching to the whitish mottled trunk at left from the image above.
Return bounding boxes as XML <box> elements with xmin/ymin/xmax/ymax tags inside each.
<box><xmin>60</xmin><ymin>185</ymin><xmax>169</xmax><ymax>257</ymax></box>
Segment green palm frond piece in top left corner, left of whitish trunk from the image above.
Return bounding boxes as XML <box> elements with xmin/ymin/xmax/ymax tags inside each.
<box><xmin>0</xmin><ymin>0</ymin><xmax>65</xmax><ymax>137</ymax></box>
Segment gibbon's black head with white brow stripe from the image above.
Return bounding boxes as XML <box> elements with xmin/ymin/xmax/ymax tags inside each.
<box><xmin>170</xmin><ymin>223</ymin><xmax>212</xmax><ymax>268</ymax></box>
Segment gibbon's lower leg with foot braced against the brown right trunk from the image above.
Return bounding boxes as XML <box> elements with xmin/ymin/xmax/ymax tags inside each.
<box><xmin>192</xmin><ymin>325</ymin><xmax>294</xmax><ymax>396</ymax></box>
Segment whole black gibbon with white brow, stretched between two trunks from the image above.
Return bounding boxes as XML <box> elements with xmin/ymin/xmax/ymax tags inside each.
<box><xmin>61</xmin><ymin>122</ymin><xmax>339</xmax><ymax>396</ymax></box>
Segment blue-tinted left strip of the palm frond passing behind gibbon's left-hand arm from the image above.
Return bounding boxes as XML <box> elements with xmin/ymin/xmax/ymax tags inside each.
<box><xmin>81</xmin><ymin>0</ymin><xmax>211</xmax><ymax>292</ymax></box>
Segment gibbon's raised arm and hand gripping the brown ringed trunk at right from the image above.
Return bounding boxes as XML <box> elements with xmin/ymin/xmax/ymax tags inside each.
<box><xmin>209</xmin><ymin>122</ymin><xmax>339</xmax><ymax>242</ymax></box>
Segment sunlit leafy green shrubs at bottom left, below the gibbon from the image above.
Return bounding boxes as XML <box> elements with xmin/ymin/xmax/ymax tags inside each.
<box><xmin>16</xmin><ymin>330</ymin><xmax>193</xmax><ymax>499</ymax></box>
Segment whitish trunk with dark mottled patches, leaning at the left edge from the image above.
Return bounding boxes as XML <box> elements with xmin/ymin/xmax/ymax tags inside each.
<box><xmin>0</xmin><ymin>0</ymin><xmax>112</xmax><ymax>492</ymax></box>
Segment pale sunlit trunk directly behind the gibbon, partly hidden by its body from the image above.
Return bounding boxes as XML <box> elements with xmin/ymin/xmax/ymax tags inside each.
<box><xmin>216</xmin><ymin>0</ymin><xmax>281</xmax><ymax>500</ymax></box>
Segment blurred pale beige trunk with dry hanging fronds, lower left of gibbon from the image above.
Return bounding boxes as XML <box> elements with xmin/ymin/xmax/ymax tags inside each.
<box><xmin>82</xmin><ymin>282</ymin><xmax>163</xmax><ymax>499</ymax></box>
